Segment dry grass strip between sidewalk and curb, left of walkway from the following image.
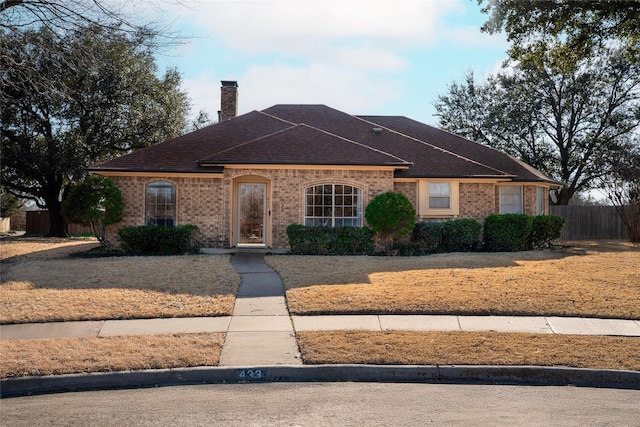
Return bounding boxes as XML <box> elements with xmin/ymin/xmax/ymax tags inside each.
<box><xmin>0</xmin><ymin>333</ymin><xmax>224</xmax><ymax>378</ymax></box>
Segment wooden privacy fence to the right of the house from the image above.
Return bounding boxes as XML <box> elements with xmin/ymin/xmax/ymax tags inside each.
<box><xmin>549</xmin><ymin>206</ymin><xmax>628</xmax><ymax>240</ymax></box>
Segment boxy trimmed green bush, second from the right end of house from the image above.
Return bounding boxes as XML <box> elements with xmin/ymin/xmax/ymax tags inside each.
<box><xmin>484</xmin><ymin>214</ymin><xmax>533</xmax><ymax>252</ymax></box>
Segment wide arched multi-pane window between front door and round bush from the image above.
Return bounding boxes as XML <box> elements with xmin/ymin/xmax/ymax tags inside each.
<box><xmin>304</xmin><ymin>184</ymin><xmax>362</xmax><ymax>227</ymax></box>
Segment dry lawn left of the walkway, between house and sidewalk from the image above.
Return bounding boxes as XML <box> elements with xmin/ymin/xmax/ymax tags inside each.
<box><xmin>0</xmin><ymin>238</ymin><xmax>240</xmax><ymax>323</ymax></box>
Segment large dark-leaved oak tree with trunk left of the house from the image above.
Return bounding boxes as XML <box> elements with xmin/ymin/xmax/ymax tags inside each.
<box><xmin>0</xmin><ymin>26</ymin><xmax>188</xmax><ymax>236</ymax></box>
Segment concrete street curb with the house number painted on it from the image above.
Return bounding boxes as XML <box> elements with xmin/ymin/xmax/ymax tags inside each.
<box><xmin>0</xmin><ymin>365</ymin><xmax>640</xmax><ymax>398</ymax></box>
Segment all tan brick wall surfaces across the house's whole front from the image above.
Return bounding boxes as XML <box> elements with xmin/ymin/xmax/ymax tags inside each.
<box><xmin>108</xmin><ymin>169</ymin><xmax>548</xmax><ymax>248</ymax></box>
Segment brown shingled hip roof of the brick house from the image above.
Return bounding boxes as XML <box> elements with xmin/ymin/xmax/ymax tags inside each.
<box><xmin>90</xmin><ymin>105</ymin><xmax>556</xmax><ymax>184</ymax></box>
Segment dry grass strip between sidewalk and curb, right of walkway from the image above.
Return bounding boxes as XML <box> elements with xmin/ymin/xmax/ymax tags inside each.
<box><xmin>297</xmin><ymin>331</ymin><xmax>640</xmax><ymax>371</ymax></box>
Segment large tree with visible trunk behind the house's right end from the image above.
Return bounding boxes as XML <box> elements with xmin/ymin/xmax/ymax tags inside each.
<box><xmin>435</xmin><ymin>51</ymin><xmax>640</xmax><ymax>205</ymax></box>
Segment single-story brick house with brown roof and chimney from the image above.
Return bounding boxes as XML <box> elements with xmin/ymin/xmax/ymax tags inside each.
<box><xmin>90</xmin><ymin>81</ymin><xmax>559</xmax><ymax>248</ymax></box>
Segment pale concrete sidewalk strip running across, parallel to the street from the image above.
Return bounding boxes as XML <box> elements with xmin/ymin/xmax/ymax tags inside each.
<box><xmin>0</xmin><ymin>311</ymin><xmax>640</xmax><ymax>340</ymax></box>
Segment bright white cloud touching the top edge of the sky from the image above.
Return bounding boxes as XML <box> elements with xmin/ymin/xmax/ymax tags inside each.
<box><xmin>182</xmin><ymin>0</ymin><xmax>459</xmax><ymax>57</ymax></box>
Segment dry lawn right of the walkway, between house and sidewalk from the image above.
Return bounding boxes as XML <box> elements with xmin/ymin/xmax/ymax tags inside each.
<box><xmin>267</xmin><ymin>241</ymin><xmax>640</xmax><ymax>319</ymax></box>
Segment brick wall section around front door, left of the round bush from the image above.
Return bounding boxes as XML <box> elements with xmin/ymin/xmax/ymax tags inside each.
<box><xmin>109</xmin><ymin>169</ymin><xmax>393</xmax><ymax>248</ymax></box>
